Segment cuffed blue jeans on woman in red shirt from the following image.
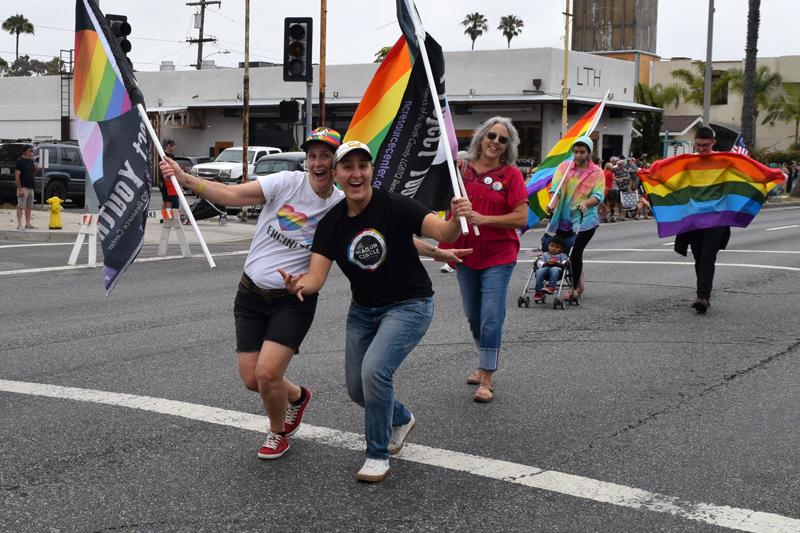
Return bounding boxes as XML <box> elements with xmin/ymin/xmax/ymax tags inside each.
<box><xmin>456</xmin><ymin>263</ymin><xmax>515</xmax><ymax>372</ymax></box>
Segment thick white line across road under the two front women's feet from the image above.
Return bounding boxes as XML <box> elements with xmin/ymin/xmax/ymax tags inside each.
<box><xmin>0</xmin><ymin>379</ymin><xmax>800</xmax><ymax>533</ymax></box>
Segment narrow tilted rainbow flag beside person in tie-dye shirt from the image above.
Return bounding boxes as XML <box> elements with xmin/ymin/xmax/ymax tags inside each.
<box><xmin>525</xmin><ymin>94</ymin><xmax>608</xmax><ymax>228</ymax></box>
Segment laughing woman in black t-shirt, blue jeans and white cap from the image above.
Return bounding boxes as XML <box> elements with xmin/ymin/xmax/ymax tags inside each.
<box><xmin>279</xmin><ymin>141</ymin><xmax>472</xmax><ymax>482</ymax></box>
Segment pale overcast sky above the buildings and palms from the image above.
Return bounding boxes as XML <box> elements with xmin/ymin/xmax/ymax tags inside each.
<box><xmin>0</xmin><ymin>0</ymin><xmax>800</xmax><ymax>70</ymax></box>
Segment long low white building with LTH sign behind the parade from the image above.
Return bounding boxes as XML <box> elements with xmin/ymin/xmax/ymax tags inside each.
<box><xmin>0</xmin><ymin>48</ymin><xmax>652</xmax><ymax>162</ymax></box>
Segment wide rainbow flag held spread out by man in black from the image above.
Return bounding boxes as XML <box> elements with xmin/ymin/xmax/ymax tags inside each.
<box><xmin>639</xmin><ymin>152</ymin><xmax>783</xmax><ymax>237</ymax></box>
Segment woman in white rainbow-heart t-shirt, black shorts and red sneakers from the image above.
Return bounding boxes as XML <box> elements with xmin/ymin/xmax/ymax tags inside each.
<box><xmin>160</xmin><ymin>128</ymin><xmax>344</xmax><ymax>459</ymax></box>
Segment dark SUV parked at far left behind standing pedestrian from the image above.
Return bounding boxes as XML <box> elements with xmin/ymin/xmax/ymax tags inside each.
<box><xmin>0</xmin><ymin>141</ymin><xmax>86</xmax><ymax>206</ymax></box>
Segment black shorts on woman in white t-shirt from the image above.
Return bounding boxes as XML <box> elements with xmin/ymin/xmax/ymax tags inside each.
<box><xmin>233</xmin><ymin>283</ymin><xmax>317</xmax><ymax>353</ymax></box>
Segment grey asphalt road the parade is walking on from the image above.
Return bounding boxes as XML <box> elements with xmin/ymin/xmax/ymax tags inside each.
<box><xmin>0</xmin><ymin>208</ymin><xmax>800</xmax><ymax>532</ymax></box>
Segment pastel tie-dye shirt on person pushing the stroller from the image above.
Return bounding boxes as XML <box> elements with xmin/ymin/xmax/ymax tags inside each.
<box><xmin>547</xmin><ymin>160</ymin><xmax>606</xmax><ymax>235</ymax></box>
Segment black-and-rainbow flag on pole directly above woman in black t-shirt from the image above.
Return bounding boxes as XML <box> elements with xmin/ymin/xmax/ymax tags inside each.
<box><xmin>344</xmin><ymin>0</ymin><xmax>458</xmax><ymax>210</ymax></box>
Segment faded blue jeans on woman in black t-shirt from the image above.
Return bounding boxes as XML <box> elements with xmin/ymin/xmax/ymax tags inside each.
<box><xmin>344</xmin><ymin>298</ymin><xmax>433</xmax><ymax>459</ymax></box>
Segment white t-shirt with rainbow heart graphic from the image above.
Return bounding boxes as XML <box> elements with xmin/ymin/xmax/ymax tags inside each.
<box><xmin>244</xmin><ymin>171</ymin><xmax>344</xmax><ymax>289</ymax></box>
